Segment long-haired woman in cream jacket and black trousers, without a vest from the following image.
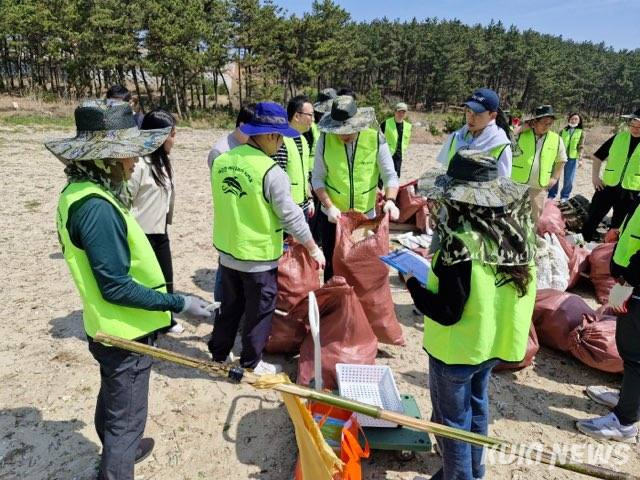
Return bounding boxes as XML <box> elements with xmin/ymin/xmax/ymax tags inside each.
<box><xmin>129</xmin><ymin>109</ymin><xmax>184</xmax><ymax>333</ymax></box>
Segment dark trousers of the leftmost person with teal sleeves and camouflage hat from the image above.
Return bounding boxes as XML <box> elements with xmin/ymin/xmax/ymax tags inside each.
<box><xmin>89</xmin><ymin>340</ymin><xmax>152</xmax><ymax>480</ymax></box>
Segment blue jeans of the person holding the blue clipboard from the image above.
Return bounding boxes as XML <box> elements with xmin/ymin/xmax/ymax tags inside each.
<box><xmin>429</xmin><ymin>356</ymin><xmax>498</xmax><ymax>480</ymax></box>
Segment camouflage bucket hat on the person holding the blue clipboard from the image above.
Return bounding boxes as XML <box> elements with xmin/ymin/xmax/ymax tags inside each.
<box><xmin>418</xmin><ymin>150</ymin><xmax>529</xmax><ymax>207</ymax></box>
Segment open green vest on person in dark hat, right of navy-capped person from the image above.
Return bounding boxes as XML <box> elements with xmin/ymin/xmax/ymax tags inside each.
<box><xmin>511</xmin><ymin>129</ymin><xmax>560</xmax><ymax>188</ymax></box>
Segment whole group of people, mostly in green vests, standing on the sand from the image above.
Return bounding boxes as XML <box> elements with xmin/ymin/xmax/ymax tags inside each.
<box><xmin>45</xmin><ymin>83</ymin><xmax>640</xmax><ymax>479</ymax></box>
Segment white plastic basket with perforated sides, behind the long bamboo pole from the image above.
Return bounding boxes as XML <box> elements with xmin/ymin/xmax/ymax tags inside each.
<box><xmin>336</xmin><ymin>363</ymin><xmax>404</xmax><ymax>428</ymax></box>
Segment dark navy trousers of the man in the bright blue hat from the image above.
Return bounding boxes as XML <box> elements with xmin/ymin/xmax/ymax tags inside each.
<box><xmin>209</xmin><ymin>265</ymin><xmax>278</xmax><ymax>368</ymax></box>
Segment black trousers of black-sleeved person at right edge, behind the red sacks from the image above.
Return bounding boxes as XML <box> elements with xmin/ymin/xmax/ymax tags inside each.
<box><xmin>582</xmin><ymin>185</ymin><xmax>637</xmax><ymax>242</ymax></box>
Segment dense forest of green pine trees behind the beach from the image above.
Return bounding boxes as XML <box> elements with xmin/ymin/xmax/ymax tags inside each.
<box><xmin>0</xmin><ymin>0</ymin><xmax>640</xmax><ymax>116</ymax></box>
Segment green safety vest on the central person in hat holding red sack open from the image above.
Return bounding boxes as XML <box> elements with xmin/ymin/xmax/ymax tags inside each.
<box><xmin>324</xmin><ymin>128</ymin><xmax>379</xmax><ymax>213</ymax></box>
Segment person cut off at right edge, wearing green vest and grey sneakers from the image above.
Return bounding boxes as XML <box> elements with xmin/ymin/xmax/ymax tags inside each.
<box><xmin>576</xmin><ymin>202</ymin><xmax>640</xmax><ymax>443</ymax></box>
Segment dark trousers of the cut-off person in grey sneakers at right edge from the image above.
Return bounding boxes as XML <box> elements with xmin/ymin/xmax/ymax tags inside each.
<box><xmin>613</xmin><ymin>297</ymin><xmax>640</xmax><ymax>425</ymax></box>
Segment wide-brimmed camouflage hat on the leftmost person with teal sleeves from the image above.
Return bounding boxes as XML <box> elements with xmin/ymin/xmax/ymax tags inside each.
<box><xmin>44</xmin><ymin>100</ymin><xmax>172</xmax><ymax>165</ymax></box>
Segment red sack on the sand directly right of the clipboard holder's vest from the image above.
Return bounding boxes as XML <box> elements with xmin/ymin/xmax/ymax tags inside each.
<box><xmin>533</xmin><ymin>289</ymin><xmax>595</xmax><ymax>352</ymax></box>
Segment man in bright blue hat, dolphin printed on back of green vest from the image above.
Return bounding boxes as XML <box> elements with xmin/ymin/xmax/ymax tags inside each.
<box><xmin>209</xmin><ymin>102</ymin><xmax>325</xmax><ymax>374</ymax></box>
